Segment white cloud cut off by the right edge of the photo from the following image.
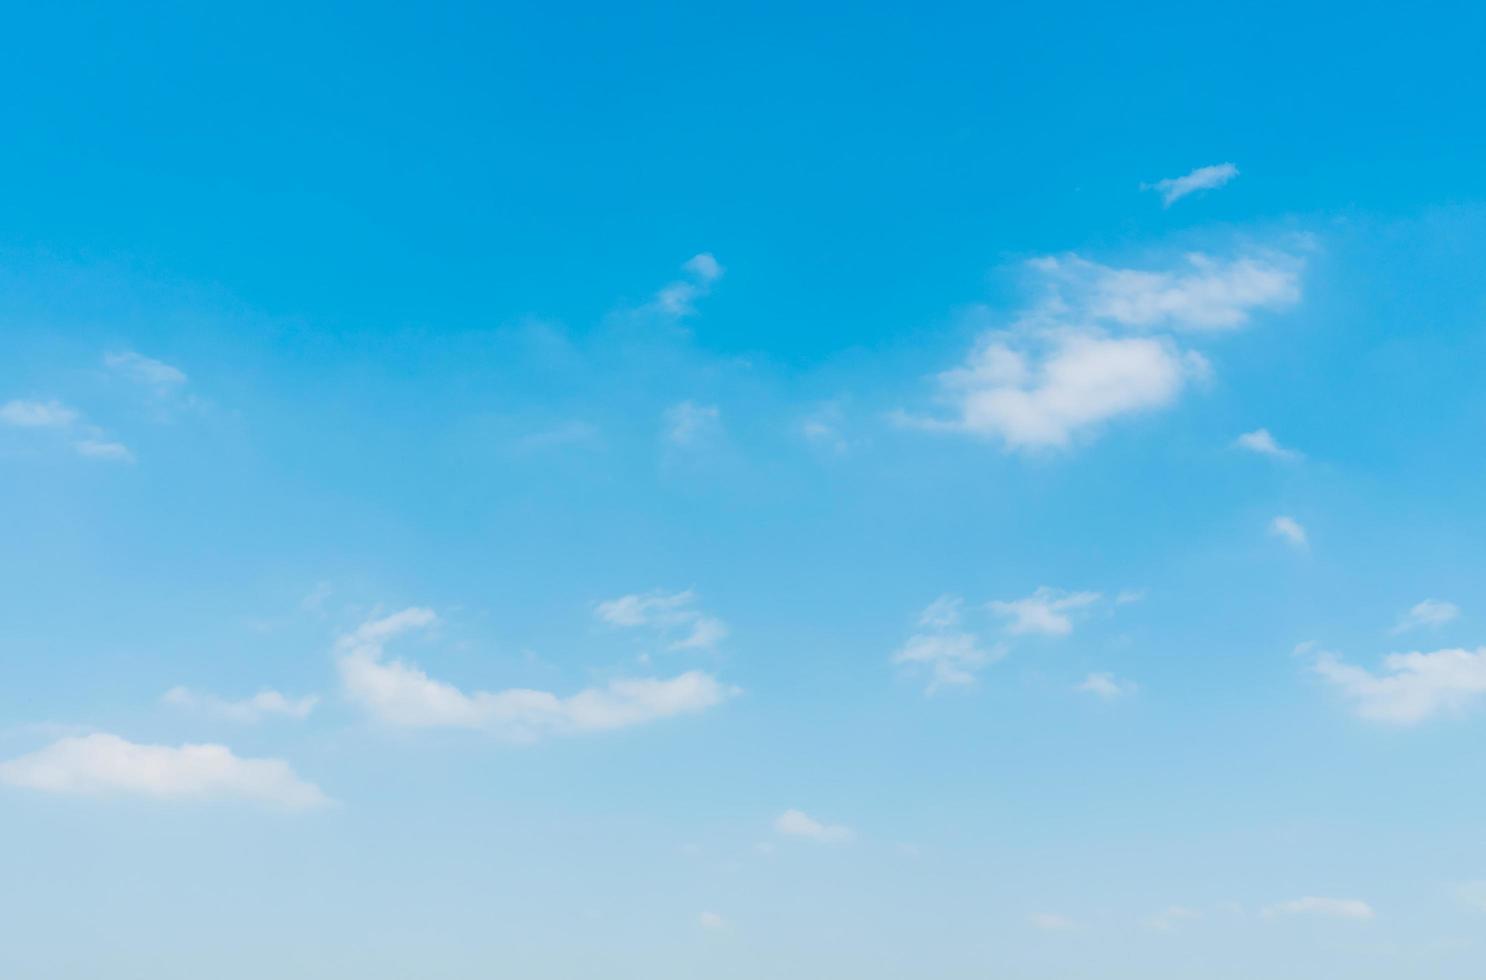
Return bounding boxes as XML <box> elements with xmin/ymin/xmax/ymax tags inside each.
<box><xmin>1314</xmin><ymin>647</ymin><xmax>1486</xmax><ymax>724</ymax></box>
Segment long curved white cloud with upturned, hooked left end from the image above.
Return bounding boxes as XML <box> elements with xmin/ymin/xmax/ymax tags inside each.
<box><xmin>336</xmin><ymin>608</ymin><xmax>736</xmax><ymax>742</ymax></box>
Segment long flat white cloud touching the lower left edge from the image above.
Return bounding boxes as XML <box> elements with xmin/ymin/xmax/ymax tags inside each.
<box><xmin>0</xmin><ymin>733</ymin><xmax>330</xmax><ymax>809</ymax></box>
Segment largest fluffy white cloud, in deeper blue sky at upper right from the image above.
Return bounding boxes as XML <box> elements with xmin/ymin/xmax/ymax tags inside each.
<box><xmin>893</xmin><ymin>253</ymin><xmax>1300</xmax><ymax>451</ymax></box>
